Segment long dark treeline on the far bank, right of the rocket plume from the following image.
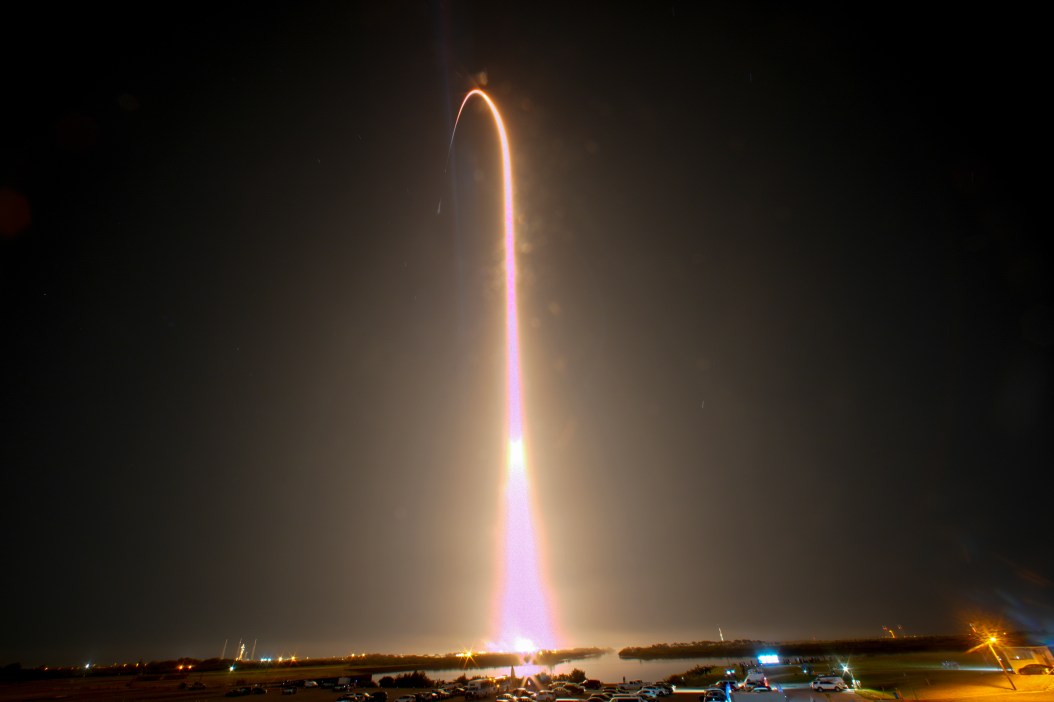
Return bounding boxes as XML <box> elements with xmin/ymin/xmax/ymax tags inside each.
<box><xmin>619</xmin><ymin>635</ymin><xmax>990</xmax><ymax>660</ymax></box>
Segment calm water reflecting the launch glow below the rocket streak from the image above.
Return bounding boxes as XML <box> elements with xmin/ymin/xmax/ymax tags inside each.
<box><xmin>419</xmin><ymin>651</ymin><xmax>739</xmax><ymax>683</ymax></box>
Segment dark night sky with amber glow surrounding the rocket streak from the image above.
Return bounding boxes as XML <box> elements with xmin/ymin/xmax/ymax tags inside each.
<box><xmin>0</xmin><ymin>2</ymin><xmax>1054</xmax><ymax>665</ymax></box>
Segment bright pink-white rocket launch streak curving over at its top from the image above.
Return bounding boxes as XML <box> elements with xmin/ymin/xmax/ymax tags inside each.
<box><xmin>451</xmin><ymin>90</ymin><xmax>558</xmax><ymax>652</ymax></box>
